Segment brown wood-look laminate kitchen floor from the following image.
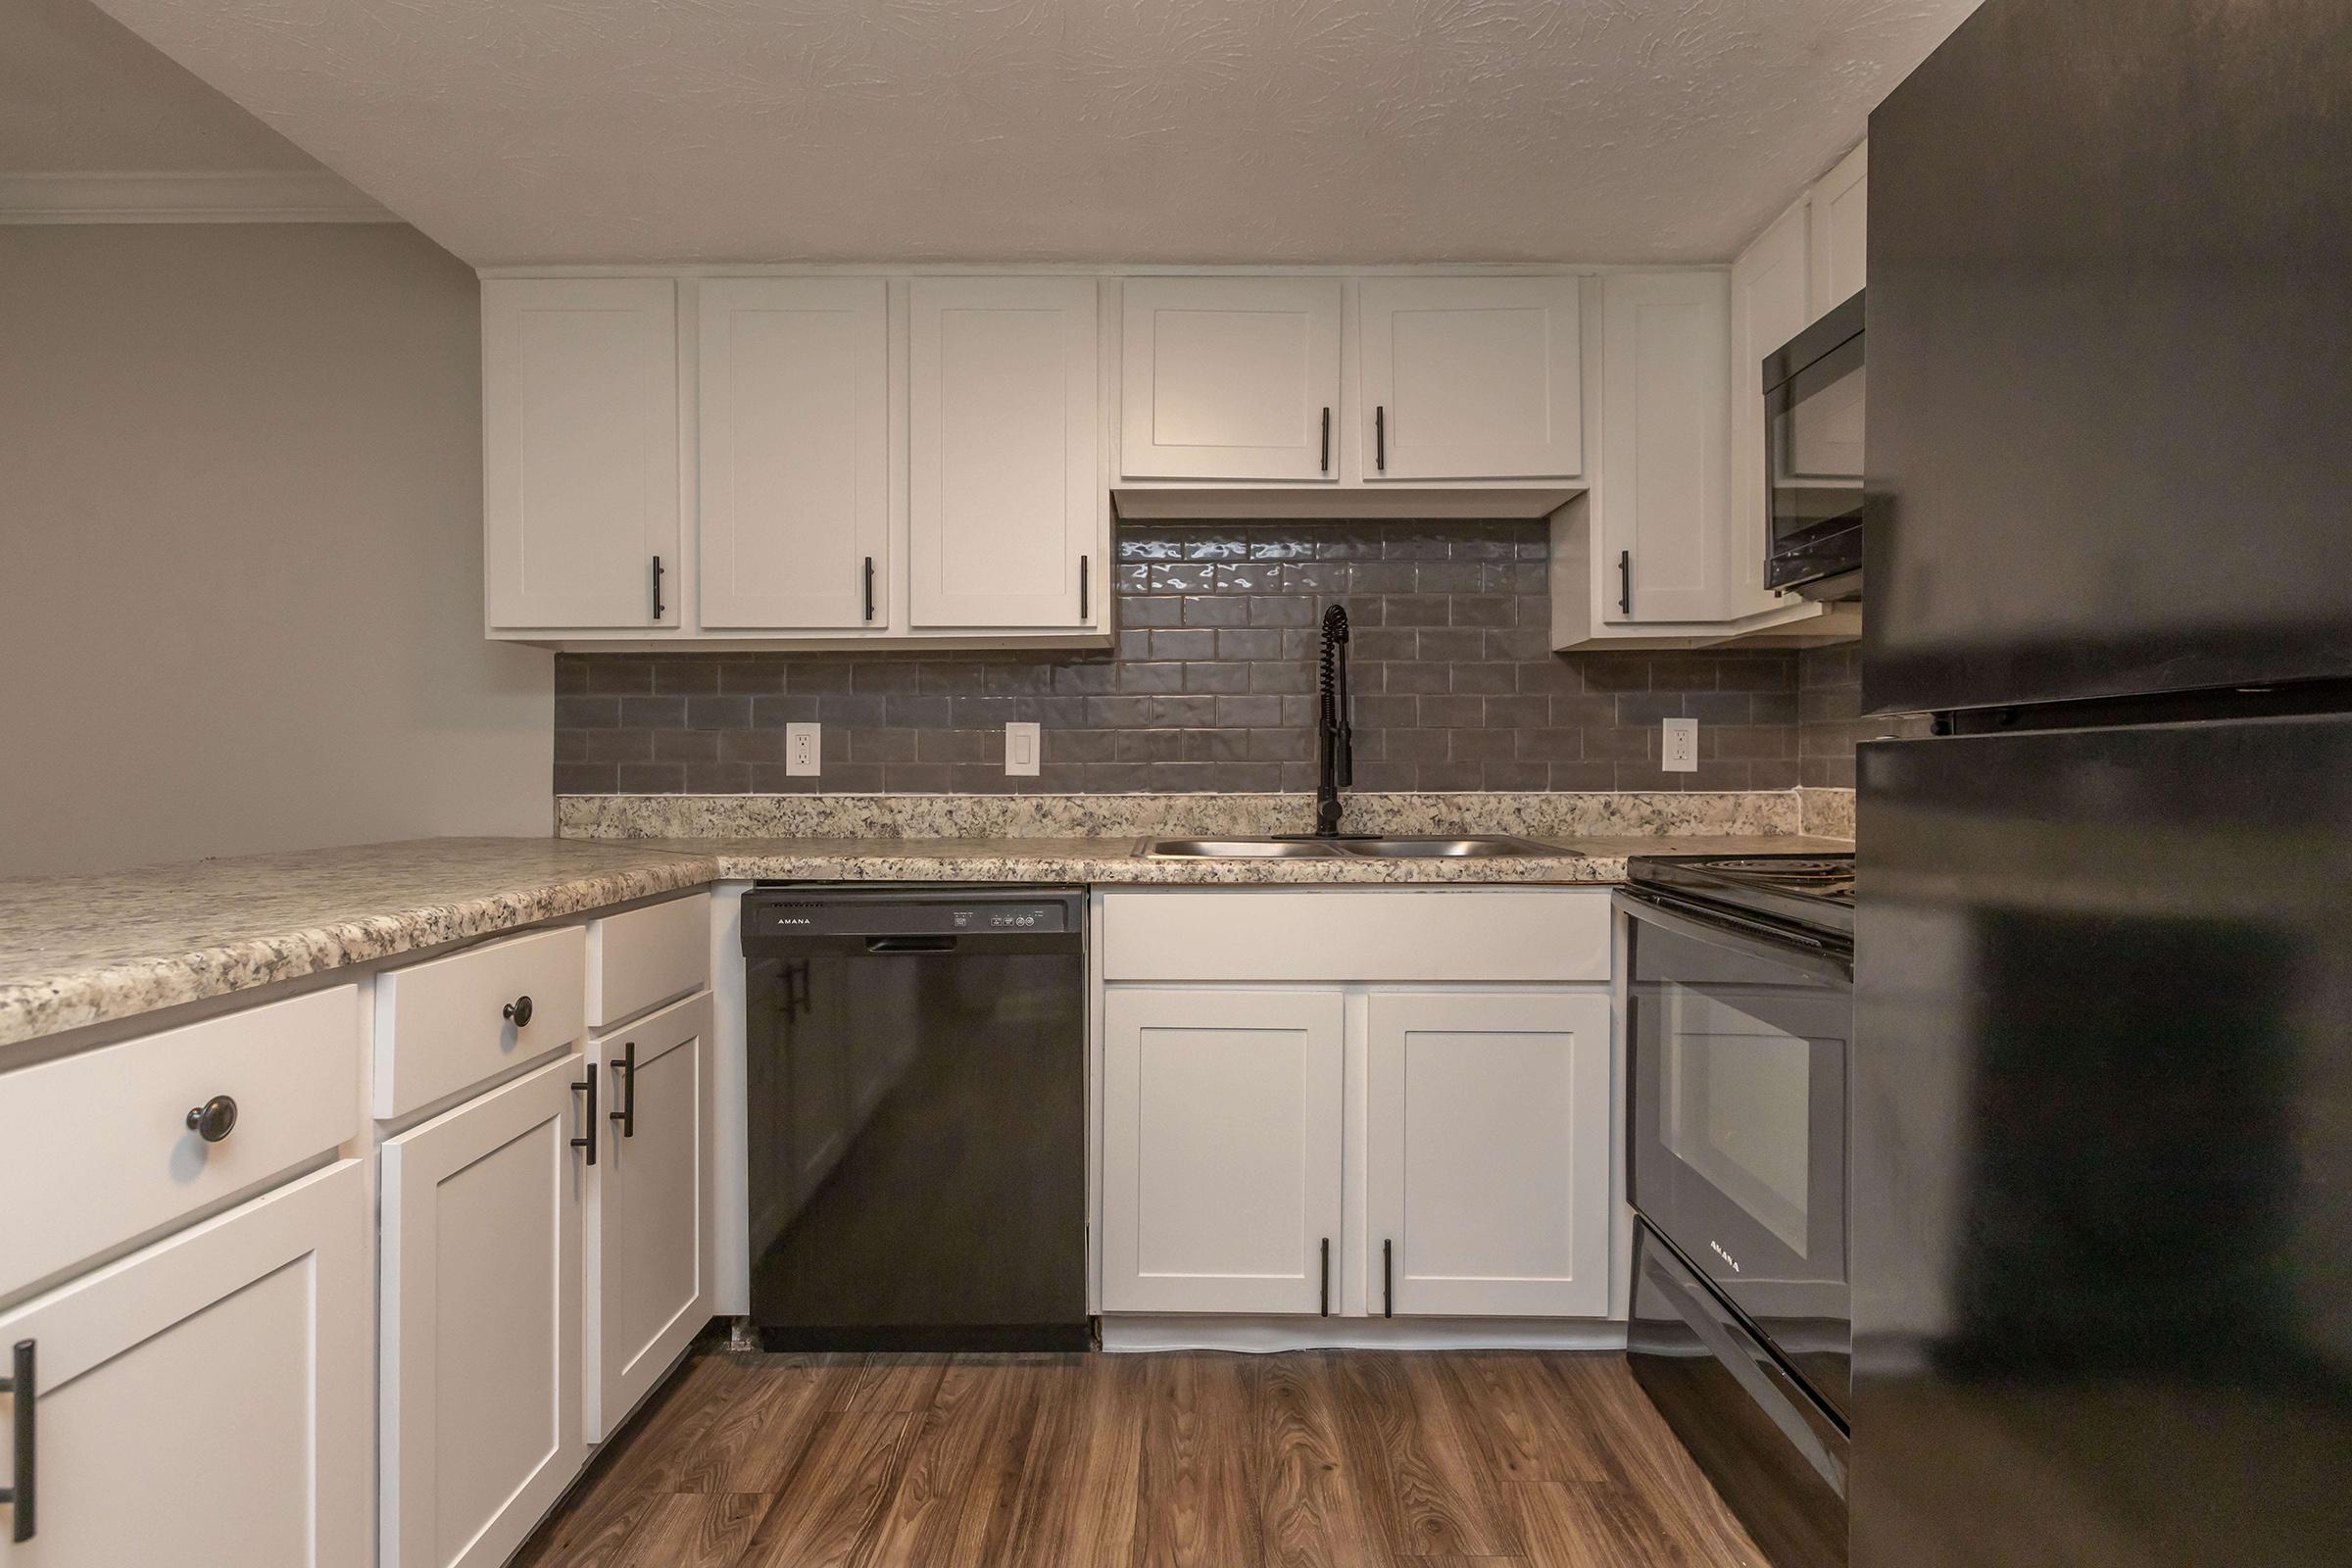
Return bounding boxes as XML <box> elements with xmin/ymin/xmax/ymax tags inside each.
<box><xmin>515</xmin><ymin>1349</ymin><xmax>1764</xmax><ymax>1568</ymax></box>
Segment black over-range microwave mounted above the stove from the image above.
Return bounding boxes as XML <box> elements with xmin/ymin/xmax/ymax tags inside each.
<box><xmin>1764</xmin><ymin>294</ymin><xmax>1863</xmax><ymax>600</ymax></box>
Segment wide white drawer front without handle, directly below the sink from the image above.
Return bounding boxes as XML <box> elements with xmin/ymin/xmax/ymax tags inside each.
<box><xmin>1103</xmin><ymin>889</ymin><xmax>1609</xmax><ymax>983</ymax></box>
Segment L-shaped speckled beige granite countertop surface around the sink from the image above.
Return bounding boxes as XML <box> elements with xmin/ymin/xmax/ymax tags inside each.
<box><xmin>0</xmin><ymin>835</ymin><xmax>1848</xmax><ymax>1046</ymax></box>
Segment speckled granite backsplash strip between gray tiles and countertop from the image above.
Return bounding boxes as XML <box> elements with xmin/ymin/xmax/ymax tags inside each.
<box><xmin>555</xmin><ymin>790</ymin><xmax>1804</xmax><ymax>839</ymax></box>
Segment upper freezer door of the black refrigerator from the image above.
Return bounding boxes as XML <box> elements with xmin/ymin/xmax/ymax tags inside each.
<box><xmin>1863</xmin><ymin>0</ymin><xmax>2352</xmax><ymax>712</ymax></box>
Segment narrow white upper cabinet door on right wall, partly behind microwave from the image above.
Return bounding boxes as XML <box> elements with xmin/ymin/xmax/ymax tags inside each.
<box><xmin>1724</xmin><ymin>205</ymin><xmax>1813</xmax><ymax>615</ymax></box>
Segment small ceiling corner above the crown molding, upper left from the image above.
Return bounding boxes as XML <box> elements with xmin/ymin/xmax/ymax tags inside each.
<box><xmin>0</xmin><ymin>0</ymin><xmax>318</xmax><ymax>174</ymax></box>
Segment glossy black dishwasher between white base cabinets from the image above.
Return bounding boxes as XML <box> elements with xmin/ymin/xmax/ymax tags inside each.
<box><xmin>743</xmin><ymin>884</ymin><xmax>1089</xmax><ymax>1349</ymax></box>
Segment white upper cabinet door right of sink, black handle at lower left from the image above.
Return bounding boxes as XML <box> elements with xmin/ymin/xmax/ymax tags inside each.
<box><xmin>1592</xmin><ymin>272</ymin><xmax>1731</xmax><ymax>623</ymax></box>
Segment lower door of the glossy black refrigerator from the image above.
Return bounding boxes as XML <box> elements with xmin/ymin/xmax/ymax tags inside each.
<box><xmin>1848</xmin><ymin>714</ymin><xmax>2352</xmax><ymax>1568</ymax></box>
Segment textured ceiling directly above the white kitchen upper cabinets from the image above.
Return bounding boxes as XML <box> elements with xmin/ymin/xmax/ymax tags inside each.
<box><xmin>82</xmin><ymin>0</ymin><xmax>1976</xmax><ymax>266</ymax></box>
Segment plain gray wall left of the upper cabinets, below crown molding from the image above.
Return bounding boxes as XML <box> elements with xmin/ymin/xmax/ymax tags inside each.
<box><xmin>0</xmin><ymin>223</ymin><xmax>553</xmax><ymax>872</ymax></box>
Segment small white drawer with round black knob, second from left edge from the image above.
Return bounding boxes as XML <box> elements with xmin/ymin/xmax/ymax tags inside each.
<box><xmin>374</xmin><ymin>926</ymin><xmax>588</xmax><ymax>1116</ymax></box>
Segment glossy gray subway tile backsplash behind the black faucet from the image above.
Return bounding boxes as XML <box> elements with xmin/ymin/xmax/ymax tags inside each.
<box><xmin>555</xmin><ymin>522</ymin><xmax>1860</xmax><ymax>795</ymax></box>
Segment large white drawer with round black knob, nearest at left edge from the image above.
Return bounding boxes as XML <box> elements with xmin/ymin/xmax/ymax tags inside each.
<box><xmin>0</xmin><ymin>985</ymin><xmax>360</xmax><ymax>1296</ymax></box>
